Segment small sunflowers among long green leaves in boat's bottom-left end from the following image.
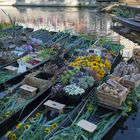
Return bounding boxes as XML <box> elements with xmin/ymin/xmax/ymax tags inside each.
<box><xmin>5</xmin><ymin>111</ymin><xmax>65</xmax><ymax>140</ymax></box>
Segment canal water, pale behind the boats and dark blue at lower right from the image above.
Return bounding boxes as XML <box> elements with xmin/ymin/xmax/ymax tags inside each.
<box><xmin>0</xmin><ymin>7</ymin><xmax>140</xmax><ymax>140</ymax></box>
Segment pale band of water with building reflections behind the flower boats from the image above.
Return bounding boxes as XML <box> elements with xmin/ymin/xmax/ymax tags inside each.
<box><xmin>0</xmin><ymin>7</ymin><xmax>111</xmax><ymax>35</ymax></box>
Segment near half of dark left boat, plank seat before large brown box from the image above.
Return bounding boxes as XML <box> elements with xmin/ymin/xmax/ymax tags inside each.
<box><xmin>0</xmin><ymin>69</ymin><xmax>52</xmax><ymax>135</ymax></box>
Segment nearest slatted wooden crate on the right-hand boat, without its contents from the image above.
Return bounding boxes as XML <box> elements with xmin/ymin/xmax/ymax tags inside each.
<box><xmin>97</xmin><ymin>83</ymin><xmax>129</xmax><ymax>109</ymax></box>
